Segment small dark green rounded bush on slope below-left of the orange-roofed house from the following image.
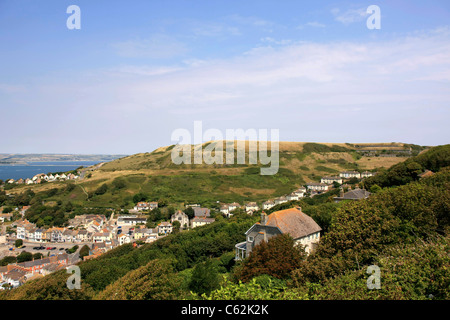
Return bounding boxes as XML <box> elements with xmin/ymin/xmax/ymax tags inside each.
<box><xmin>189</xmin><ymin>259</ymin><xmax>220</xmax><ymax>295</ymax></box>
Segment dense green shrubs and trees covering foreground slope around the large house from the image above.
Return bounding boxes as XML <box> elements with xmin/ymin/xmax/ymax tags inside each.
<box><xmin>0</xmin><ymin>145</ymin><xmax>450</xmax><ymax>300</ymax></box>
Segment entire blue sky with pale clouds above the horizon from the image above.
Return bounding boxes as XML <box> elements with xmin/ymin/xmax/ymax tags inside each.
<box><xmin>0</xmin><ymin>0</ymin><xmax>450</xmax><ymax>154</ymax></box>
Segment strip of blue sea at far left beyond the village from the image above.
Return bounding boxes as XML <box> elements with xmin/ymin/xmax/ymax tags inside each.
<box><xmin>0</xmin><ymin>161</ymin><xmax>102</xmax><ymax>181</ymax></box>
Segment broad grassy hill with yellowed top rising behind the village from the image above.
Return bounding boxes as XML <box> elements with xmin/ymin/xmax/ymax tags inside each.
<box><xmin>4</xmin><ymin>142</ymin><xmax>414</xmax><ymax>208</ymax></box>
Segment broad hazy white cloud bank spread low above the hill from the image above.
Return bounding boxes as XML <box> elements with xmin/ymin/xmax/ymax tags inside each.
<box><xmin>2</xmin><ymin>30</ymin><xmax>450</xmax><ymax>152</ymax></box>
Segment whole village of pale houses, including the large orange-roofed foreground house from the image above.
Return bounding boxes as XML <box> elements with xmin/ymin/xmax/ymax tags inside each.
<box><xmin>0</xmin><ymin>171</ymin><xmax>374</xmax><ymax>290</ymax></box>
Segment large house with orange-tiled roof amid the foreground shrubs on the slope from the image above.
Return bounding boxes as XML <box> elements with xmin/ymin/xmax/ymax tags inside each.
<box><xmin>235</xmin><ymin>207</ymin><xmax>322</xmax><ymax>260</ymax></box>
